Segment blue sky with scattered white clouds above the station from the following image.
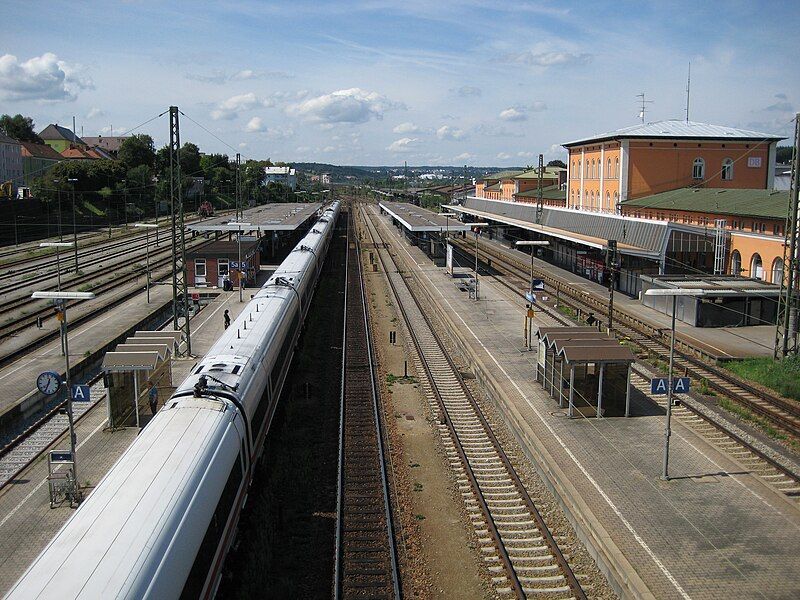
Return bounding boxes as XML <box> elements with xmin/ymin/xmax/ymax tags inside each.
<box><xmin>0</xmin><ymin>0</ymin><xmax>800</xmax><ymax>166</ymax></box>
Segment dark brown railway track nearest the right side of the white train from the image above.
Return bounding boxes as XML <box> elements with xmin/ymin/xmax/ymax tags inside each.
<box><xmin>334</xmin><ymin>210</ymin><xmax>401</xmax><ymax>600</ymax></box>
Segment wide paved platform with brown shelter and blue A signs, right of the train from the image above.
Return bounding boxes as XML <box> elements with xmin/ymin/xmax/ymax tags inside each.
<box><xmin>374</xmin><ymin>206</ymin><xmax>800</xmax><ymax>599</ymax></box>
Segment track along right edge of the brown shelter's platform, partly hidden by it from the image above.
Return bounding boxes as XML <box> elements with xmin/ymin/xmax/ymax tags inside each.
<box><xmin>450</xmin><ymin>237</ymin><xmax>800</xmax><ymax>503</ymax></box>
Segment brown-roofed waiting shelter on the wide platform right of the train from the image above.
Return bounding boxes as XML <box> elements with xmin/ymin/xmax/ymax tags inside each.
<box><xmin>536</xmin><ymin>327</ymin><xmax>636</xmax><ymax>417</ymax></box>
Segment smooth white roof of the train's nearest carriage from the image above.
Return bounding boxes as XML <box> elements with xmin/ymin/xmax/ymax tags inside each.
<box><xmin>8</xmin><ymin>398</ymin><xmax>238</xmax><ymax>599</ymax></box>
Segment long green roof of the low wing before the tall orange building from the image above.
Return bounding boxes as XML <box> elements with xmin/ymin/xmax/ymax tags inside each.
<box><xmin>622</xmin><ymin>188</ymin><xmax>789</xmax><ymax>219</ymax></box>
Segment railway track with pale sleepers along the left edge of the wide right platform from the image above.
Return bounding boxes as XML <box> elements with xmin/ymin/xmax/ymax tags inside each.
<box><xmin>363</xmin><ymin>204</ymin><xmax>586</xmax><ymax>598</ymax></box>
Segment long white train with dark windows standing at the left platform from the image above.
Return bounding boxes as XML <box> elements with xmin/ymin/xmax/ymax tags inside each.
<box><xmin>8</xmin><ymin>202</ymin><xmax>339</xmax><ymax>600</ymax></box>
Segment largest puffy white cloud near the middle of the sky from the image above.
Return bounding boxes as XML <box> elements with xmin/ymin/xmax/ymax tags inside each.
<box><xmin>287</xmin><ymin>88</ymin><xmax>405</xmax><ymax>124</ymax></box>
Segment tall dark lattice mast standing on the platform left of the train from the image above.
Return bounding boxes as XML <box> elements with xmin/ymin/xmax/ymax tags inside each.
<box><xmin>169</xmin><ymin>106</ymin><xmax>192</xmax><ymax>356</ymax></box>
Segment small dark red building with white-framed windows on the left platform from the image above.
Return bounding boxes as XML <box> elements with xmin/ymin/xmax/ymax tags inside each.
<box><xmin>186</xmin><ymin>237</ymin><xmax>261</xmax><ymax>288</ymax></box>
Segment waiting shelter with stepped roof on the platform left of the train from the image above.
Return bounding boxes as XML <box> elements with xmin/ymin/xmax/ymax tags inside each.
<box><xmin>102</xmin><ymin>331</ymin><xmax>181</xmax><ymax>429</ymax></box>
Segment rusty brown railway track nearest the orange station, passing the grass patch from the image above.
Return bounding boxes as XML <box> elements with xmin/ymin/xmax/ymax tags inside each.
<box><xmin>456</xmin><ymin>241</ymin><xmax>800</xmax><ymax>437</ymax></box>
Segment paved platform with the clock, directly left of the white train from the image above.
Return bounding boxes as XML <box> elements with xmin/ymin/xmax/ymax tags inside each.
<box><xmin>0</xmin><ymin>292</ymin><xmax>249</xmax><ymax>596</ymax></box>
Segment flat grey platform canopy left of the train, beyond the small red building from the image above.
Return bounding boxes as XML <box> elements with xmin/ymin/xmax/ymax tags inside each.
<box><xmin>187</xmin><ymin>202</ymin><xmax>322</xmax><ymax>233</ymax></box>
